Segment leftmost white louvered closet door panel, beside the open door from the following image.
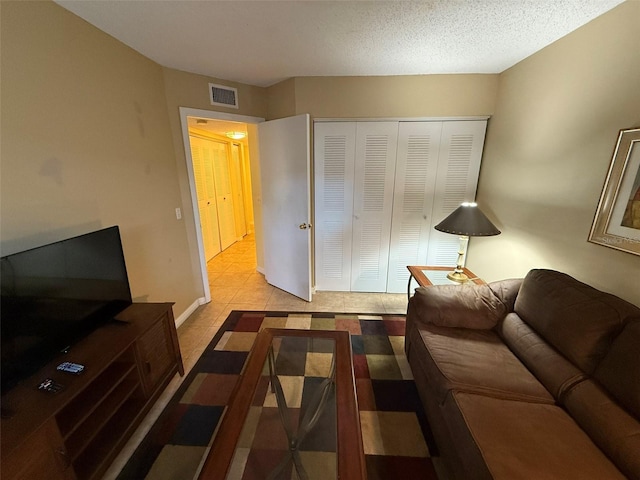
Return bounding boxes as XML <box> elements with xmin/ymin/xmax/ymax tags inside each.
<box><xmin>314</xmin><ymin>122</ymin><xmax>356</xmax><ymax>291</ymax></box>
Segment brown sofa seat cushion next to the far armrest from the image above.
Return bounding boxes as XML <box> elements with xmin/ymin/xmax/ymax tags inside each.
<box><xmin>409</xmin><ymin>325</ymin><xmax>554</xmax><ymax>403</ymax></box>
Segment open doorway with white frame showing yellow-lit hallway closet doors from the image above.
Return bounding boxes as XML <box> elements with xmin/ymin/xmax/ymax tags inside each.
<box><xmin>180</xmin><ymin>107</ymin><xmax>264</xmax><ymax>303</ymax></box>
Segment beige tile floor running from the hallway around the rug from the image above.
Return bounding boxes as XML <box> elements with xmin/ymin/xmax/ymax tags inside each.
<box><xmin>103</xmin><ymin>235</ymin><xmax>408</xmax><ymax>480</ymax></box>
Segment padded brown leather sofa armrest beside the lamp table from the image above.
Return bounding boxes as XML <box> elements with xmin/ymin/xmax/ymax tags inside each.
<box><xmin>407</xmin><ymin>282</ymin><xmax>513</xmax><ymax>330</ymax></box>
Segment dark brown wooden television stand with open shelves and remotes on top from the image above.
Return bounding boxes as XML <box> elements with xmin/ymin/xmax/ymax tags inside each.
<box><xmin>0</xmin><ymin>303</ymin><xmax>184</xmax><ymax>480</ymax></box>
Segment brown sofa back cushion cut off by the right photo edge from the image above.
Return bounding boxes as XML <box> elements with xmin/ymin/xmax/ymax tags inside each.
<box><xmin>594</xmin><ymin>320</ymin><xmax>640</xmax><ymax>418</ymax></box>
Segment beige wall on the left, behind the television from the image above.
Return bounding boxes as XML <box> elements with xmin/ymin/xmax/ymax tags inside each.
<box><xmin>0</xmin><ymin>1</ymin><xmax>197</xmax><ymax>315</ymax></box>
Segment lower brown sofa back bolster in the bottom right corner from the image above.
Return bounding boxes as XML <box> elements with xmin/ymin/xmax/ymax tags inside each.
<box><xmin>563</xmin><ymin>380</ymin><xmax>640</xmax><ymax>478</ymax></box>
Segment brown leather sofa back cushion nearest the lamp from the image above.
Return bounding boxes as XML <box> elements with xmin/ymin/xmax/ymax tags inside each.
<box><xmin>514</xmin><ymin>270</ymin><xmax>640</xmax><ymax>374</ymax></box>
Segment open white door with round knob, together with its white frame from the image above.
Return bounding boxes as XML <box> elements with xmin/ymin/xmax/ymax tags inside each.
<box><xmin>179</xmin><ymin>107</ymin><xmax>312</xmax><ymax>304</ymax></box>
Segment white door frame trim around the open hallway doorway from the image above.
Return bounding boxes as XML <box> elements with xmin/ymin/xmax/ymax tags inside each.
<box><xmin>179</xmin><ymin>107</ymin><xmax>265</xmax><ymax>303</ymax></box>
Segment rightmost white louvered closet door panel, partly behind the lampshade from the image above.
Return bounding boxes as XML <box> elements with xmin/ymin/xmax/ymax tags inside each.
<box><xmin>427</xmin><ymin>120</ymin><xmax>487</xmax><ymax>266</ymax></box>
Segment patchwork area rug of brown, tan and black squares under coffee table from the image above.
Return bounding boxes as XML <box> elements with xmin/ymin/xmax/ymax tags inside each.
<box><xmin>118</xmin><ymin>311</ymin><xmax>437</xmax><ymax>480</ymax></box>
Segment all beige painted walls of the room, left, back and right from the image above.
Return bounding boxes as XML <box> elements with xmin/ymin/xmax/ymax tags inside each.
<box><xmin>0</xmin><ymin>1</ymin><xmax>640</xmax><ymax>315</ymax></box>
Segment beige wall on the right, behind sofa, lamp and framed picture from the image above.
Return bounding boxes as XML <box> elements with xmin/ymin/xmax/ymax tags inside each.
<box><xmin>467</xmin><ymin>1</ymin><xmax>640</xmax><ymax>304</ymax></box>
